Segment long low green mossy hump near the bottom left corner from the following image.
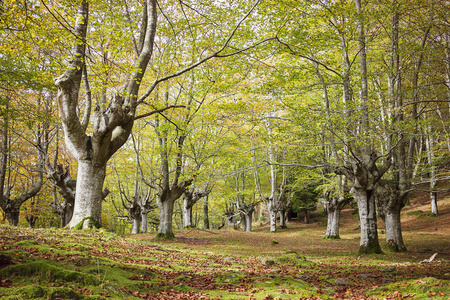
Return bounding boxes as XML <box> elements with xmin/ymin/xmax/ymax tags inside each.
<box><xmin>0</xmin><ymin>262</ymin><xmax>100</xmax><ymax>285</ymax></box>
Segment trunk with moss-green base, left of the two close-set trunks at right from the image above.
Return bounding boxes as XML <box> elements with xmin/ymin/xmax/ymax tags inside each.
<box><xmin>353</xmin><ymin>188</ymin><xmax>383</xmax><ymax>254</ymax></box>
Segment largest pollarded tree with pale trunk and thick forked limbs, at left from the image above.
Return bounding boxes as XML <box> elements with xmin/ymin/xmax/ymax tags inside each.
<box><xmin>55</xmin><ymin>0</ymin><xmax>274</xmax><ymax>229</ymax></box>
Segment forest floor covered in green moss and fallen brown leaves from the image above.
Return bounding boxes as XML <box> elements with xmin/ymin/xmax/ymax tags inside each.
<box><xmin>0</xmin><ymin>194</ymin><xmax>450</xmax><ymax>300</ymax></box>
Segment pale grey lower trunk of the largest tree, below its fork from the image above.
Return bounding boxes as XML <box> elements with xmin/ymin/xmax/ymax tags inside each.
<box><xmin>68</xmin><ymin>160</ymin><xmax>106</xmax><ymax>228</ymax></box>
